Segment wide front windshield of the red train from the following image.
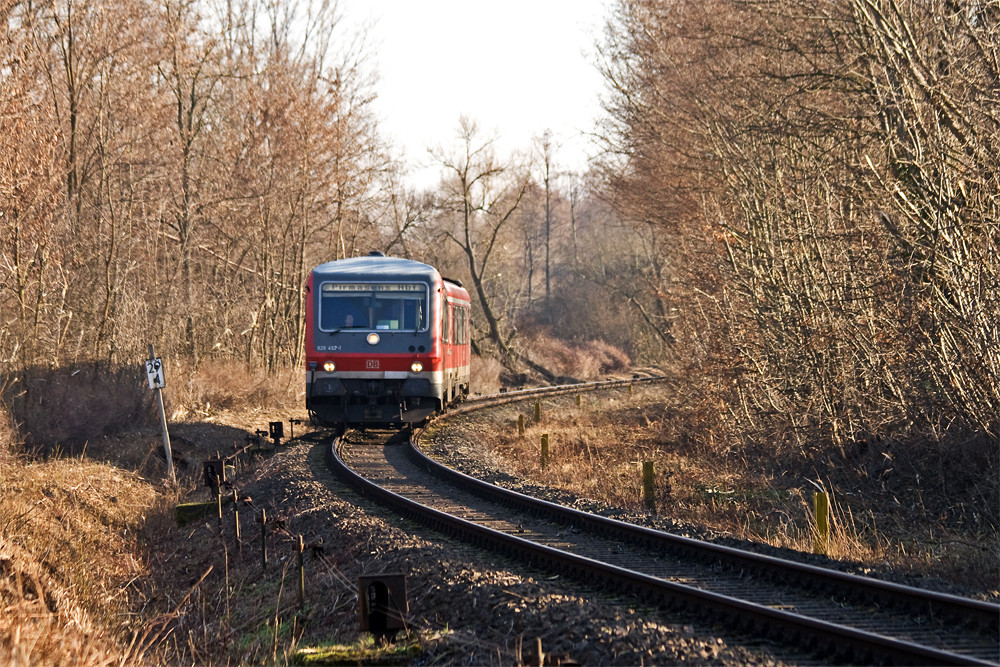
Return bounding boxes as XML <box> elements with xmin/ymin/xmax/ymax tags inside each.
<box><xmin>319</xmin><ymin>283</ymin><xmax>427</xmax><ymax>332</ymax></box>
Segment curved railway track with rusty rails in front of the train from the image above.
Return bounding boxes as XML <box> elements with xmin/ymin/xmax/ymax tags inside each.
<box><xmin>328</xmin><ymin>385</ymin><xmax>1000</xmax><ymax>665</ymax></box>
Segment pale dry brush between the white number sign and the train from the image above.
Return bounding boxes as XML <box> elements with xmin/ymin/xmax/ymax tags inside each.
<box><xmin>165</xmin><ymin>359</ymin><xmax>305</xmax><ymax>419</ymax></box>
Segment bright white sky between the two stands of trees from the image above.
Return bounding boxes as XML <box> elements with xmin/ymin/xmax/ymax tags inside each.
<box><xmin>340</xmin><ymin>0</ymin><xmax>611</xmax><ymax>186</ymax></box>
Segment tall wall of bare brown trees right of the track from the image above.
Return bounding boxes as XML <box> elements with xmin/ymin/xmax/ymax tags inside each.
<box><xmin>604</xmin><ymin>0</ymin><xmax>998</xmax><ymax>442</ymax></box>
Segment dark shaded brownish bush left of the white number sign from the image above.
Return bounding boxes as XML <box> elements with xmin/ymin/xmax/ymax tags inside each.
<box><xmin>0</xmin><ymin>362</ymin><xmax>156</xmax><ymax>451</ymax></box>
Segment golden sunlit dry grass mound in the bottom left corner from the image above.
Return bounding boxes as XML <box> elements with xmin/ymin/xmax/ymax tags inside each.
<box><xmin>0</xmin><ymin>457</ymin><xmax>155</xmax><ymax>667</ymax></box>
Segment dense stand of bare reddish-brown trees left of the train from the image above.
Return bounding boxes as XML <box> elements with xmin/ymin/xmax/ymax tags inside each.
<box><xmin>0</xmin><ymin>0</ymin><xmax>389</xmax><ymax>376</ymax></box>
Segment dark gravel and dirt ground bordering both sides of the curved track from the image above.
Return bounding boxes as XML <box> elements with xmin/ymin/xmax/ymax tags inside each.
<box><xmin>72</xmin><ymin>388</ymin><xmax>989</xmax><ymax>665</ymax></box>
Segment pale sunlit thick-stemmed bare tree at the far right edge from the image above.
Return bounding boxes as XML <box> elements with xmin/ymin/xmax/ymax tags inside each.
<box><xmin>850</xmin><ymin>0</ymin><xmax>1000</xmax><ymax>434</ymax></box>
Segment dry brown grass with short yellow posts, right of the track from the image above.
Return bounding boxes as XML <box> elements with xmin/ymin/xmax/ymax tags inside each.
<box><xmin>476</xmin><ymin>386</ymin><xmax>1000</xmax><ymax>592</ymax></box>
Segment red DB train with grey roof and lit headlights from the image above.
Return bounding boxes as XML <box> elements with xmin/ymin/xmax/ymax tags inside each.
<box><xmin>305</xmin><ymin>253</ymin><xmax>470</xmax><ymax>426</ymax></box>
